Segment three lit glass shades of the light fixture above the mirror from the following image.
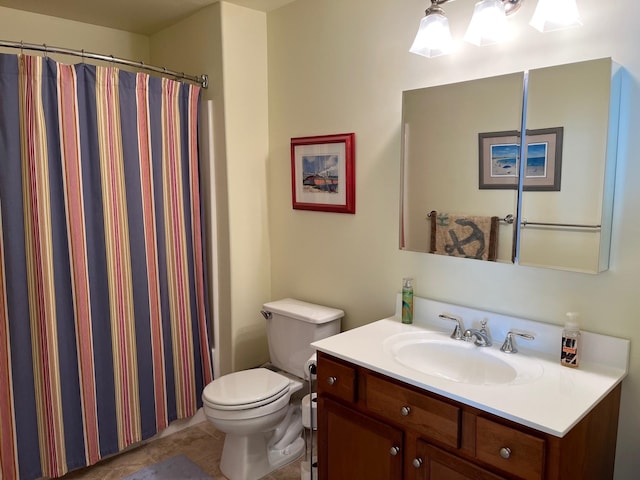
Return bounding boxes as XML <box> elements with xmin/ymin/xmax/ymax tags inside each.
<box><xmin>409</xmin><ymin>0</ymin><xmax>582</xmax><ymax>58</ymax></box>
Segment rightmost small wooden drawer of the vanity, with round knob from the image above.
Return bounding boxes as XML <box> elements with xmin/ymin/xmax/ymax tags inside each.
<box><xmin>476</xmin><ymin>417</ymin><xmax>545</xmax><ymax>480</ymax></box>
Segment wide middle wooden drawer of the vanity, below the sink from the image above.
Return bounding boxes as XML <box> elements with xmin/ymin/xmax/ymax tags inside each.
<box><xmin>366</xmin><ymin>375</ymin><xmax>460</xmax><ymax>448</ymax></box>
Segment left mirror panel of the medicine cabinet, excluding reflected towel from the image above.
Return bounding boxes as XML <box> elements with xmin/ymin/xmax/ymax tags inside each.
<box><xmin>400</xmin><ymin>72</ymin><xmax>524</xmax><ymax>262</ymax></box>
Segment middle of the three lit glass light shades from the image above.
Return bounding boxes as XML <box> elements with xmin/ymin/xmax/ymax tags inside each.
<box><xmin>464</xmin><ymin>0</ymin><xmax>507</xmax><ymax>46</ymax></box>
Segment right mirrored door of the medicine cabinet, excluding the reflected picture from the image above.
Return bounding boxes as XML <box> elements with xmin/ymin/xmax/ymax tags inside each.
<box><xmin>519</xmin><ymin>59</ymin><xmax>620</xmax><ymax>273</ymax></box>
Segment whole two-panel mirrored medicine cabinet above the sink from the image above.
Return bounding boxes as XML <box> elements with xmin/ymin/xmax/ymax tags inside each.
<box><xmin>400</xmin><ymin>59</ymin><xmax>619</xmax><ymax>272</ymax></box>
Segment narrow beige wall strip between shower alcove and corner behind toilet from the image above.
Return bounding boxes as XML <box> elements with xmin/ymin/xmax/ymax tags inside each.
<box><xmin>220</xmin><ymin>2</ymin><xmax>271</xmax><ymax>370</ymax></box>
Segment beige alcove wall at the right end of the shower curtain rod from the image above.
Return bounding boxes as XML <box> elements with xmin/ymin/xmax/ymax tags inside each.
<box><xmin>150</xmin><ymin>3</ymin><xmax>233</xmax><ymax>375</ymax></box>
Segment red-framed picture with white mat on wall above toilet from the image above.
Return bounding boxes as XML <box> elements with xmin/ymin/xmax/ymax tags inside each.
<box><xmin>291</xmin><ymin>133</ymin><xmax>356</xmax><ymax>214</ymax></box>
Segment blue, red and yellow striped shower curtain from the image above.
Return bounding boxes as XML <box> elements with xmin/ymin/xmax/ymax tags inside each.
<box><xmin>0</xmin><ymin>54</ymin><xmax>212</xmax><ymax>480</ymax></box>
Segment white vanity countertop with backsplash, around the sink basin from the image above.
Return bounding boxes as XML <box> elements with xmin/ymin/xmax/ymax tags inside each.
<box><xmin>312</xmin><ymin>298</ymin><xmax>630</xmax><ymax>437</ymax></box>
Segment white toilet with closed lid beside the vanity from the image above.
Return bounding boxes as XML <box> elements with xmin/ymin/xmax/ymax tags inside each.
<box><xmin>202</xmin><ymin>298</ymin><xmax>344</xmax><ymax>480</ymax></box>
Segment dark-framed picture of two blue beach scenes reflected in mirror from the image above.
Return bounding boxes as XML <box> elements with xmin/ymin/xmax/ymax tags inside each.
<box><xmin>478</xmin><ymin>127</ymin><xmax>564</xmax><ymax>191</ymax></box>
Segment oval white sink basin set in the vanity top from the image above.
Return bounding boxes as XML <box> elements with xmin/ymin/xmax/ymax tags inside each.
<box><xmin>383</xmin><ymin>331</ymin><xmax>543</xmax><ymax>385</ymax></box>
